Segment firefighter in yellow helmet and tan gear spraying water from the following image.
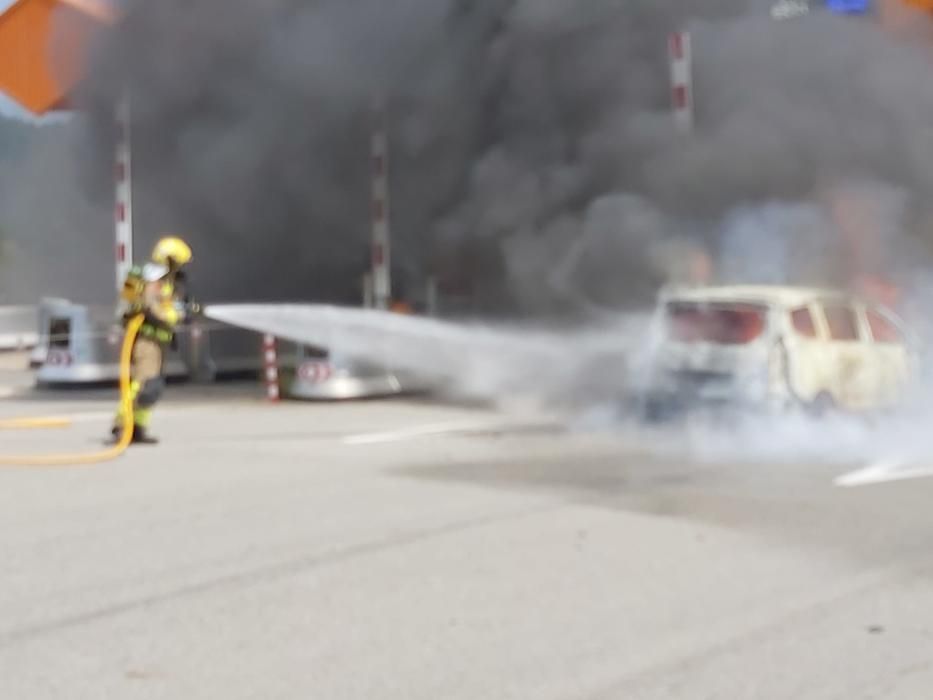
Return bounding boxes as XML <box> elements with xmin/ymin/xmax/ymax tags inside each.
<box><xmin>111</xmin><ymin>236</ymin><xmax>198</xmax><ymax>445</ymax></box>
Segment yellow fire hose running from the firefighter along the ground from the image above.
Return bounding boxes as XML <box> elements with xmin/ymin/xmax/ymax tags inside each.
<box><xmin>0</xmin><ymin>315</ymin><xmax>143</xmax><ymax>467</ymax></box>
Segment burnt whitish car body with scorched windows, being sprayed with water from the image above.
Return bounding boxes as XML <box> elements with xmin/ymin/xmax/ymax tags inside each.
<box><xmin>641</xmin><ymin>286</ymin><xmax>912</xmax><ymax>418</ymax></box>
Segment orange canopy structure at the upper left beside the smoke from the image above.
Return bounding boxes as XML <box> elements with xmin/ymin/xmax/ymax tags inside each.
<box><xmin>0</xmin><ymin>0</ymin><xmax>117</xmax><ymax>115</ymax></box>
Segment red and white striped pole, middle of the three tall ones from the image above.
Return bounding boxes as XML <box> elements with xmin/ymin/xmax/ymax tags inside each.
<box><xmin>371</xmin><ymin>101</ymin><xmax>392</xmax><ymax>309</ymax></box>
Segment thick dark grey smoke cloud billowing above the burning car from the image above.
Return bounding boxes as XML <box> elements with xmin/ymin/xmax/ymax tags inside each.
<box><xmin>62</xmin><ymin>0</ymin><xmax>933</xmax><ymax>310</ymax></box>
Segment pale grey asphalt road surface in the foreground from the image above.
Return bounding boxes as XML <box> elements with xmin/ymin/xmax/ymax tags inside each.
<box><xmin>0</xmin><ymin>358</ymin><xmax>933</xmax><ymax>700</ymax></box>
